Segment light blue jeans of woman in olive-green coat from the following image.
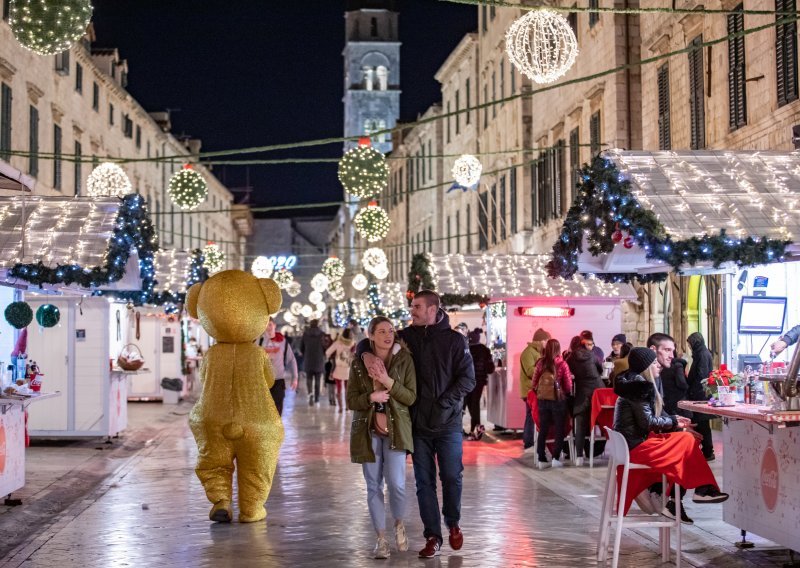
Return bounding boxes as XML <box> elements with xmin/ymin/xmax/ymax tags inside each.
<box><xmin>361</xmin><ymin>434</ymin><xmax>406</xmax><ymax>533</ymax></box>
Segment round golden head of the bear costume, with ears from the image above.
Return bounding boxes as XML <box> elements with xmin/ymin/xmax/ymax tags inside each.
<box><xmin>186</xmin><ymin>270</ymin><xmax>281</xmax><ymax>343</ymax></box>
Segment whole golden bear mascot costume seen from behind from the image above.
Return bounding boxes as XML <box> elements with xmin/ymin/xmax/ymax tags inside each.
<box><xmin>186</xmin><ymin>270</ymin><xmax>283</xmax><ymax>523</ymax></box>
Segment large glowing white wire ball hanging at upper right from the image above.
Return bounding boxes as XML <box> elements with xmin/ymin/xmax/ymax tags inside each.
<box><xmin>506</xmin><ymin>10</ymin><xmax>578</xmax><ymax>84</ymax></box>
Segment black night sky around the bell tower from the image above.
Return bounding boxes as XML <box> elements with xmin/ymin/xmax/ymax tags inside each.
<box><xmin>93</xmin><ymin>0</ymin><xmax>477</xmax><ymax>216</ymax></box>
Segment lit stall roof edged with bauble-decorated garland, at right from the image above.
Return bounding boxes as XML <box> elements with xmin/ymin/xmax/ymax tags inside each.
<box><xmin>548</xmin><ymin>150</ymin><xmax>800</xmax><ymax>282</ymax></box>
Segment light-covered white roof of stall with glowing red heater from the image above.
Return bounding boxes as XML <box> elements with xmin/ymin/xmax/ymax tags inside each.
<box><xmin>430</xmin><ymin>254</ymin><xmax>637</xmax><ymax>300</ymax></box>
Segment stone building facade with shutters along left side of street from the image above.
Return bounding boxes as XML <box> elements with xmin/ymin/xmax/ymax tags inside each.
<box><xmin>0</xmin><ymin>21</ymin><xmax>250</xmax><ymax>267</ymax></box>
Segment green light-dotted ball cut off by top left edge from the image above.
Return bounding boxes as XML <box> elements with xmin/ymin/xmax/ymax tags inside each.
<box><xmin>8</xmin><ymin>0</ymin><xmax>92</xmax><ymax>55</ymax></box>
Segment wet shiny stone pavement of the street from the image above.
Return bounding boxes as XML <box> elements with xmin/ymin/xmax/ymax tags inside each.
<box><xmin>0</xmin><ymin>394</ymin><xmax>787</xmax><ymax>568</ymax></box>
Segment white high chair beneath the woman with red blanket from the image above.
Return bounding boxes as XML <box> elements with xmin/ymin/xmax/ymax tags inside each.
<box><xmin>597</xmin><ymin>427</ymin><xmax>681</xmax><ymax>568</ymax></box>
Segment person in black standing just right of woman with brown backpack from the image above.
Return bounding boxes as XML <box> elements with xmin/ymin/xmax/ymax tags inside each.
<box><xmin>566</xmin><ymin>340</ymin><xmax>604</xmax><ymax>467</ymax></box>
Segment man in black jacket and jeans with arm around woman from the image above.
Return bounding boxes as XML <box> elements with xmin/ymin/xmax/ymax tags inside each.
<box><xmin>358</xmin><ymin>290</ymin><xmax>475</xmax><ymax>558</ymax></box>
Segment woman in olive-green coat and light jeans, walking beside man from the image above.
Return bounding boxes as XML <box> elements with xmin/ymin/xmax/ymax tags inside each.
<box><xmin>347</xmin><ymin>316</ymin><xmax>417</xmax><ymax>558</ymax></box>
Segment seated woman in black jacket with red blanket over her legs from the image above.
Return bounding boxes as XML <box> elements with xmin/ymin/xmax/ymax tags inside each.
<box><xmin>614</xmin><ymin>347</ymin><xmax>728</xmax><ymax>524</ymax></box>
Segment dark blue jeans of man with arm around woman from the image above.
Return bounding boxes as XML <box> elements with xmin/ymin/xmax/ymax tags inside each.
<box><xmin>412</xmin><ymin>430</ymin><xmax>464</xmax><ymax>543</ymax></box>
